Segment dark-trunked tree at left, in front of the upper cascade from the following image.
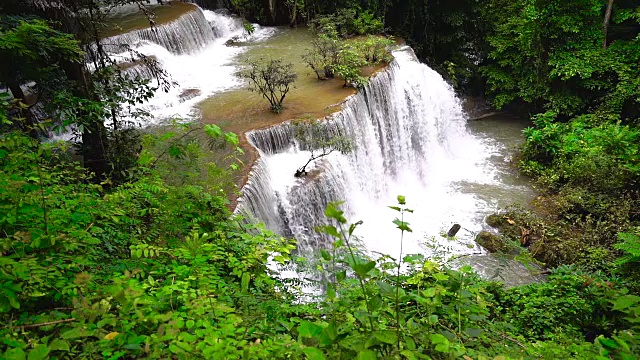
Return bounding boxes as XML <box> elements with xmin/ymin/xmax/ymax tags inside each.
<box><xmin>3</xmin><ymin>0</ymin><xmax>170</xmax><ymax>180</ymax></box>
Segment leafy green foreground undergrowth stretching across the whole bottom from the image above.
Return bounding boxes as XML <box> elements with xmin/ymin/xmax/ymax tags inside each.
<box><xmin>0</xmin><ymin>125</ymin><xmax>640</xmax><ymax>359</ymax></box>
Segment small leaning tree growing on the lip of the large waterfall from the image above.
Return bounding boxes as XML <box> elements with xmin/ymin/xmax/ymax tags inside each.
<box><xmin>293</xmin><ymin>119</ymin><xmax>353</xmax><ymax>177</ymax></box>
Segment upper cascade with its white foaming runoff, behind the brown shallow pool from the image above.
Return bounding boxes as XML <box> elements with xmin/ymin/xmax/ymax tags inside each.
<box><xmin>103</xmin><ymin>7</ymin><xmax>275</xmax><ymax>122</ymax></box>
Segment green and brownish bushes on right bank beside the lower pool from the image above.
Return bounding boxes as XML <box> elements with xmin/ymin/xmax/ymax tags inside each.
<box><xmin>520</xmin><ymin>112</ymin><xmax>640</xmax><ymax>268</ymax></box>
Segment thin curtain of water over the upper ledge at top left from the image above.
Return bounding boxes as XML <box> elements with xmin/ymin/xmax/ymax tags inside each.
<box><xmin>102</xmin><ymin>7</ymin><xmax>220</xmax><ymax>54</ymax></box>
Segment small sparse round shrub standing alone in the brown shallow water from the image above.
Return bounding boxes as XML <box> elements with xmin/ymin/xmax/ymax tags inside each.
<box><xmin>240</xmin><ymin>59</ymin><xmax>298</xmax><ymax>114</ymax></box>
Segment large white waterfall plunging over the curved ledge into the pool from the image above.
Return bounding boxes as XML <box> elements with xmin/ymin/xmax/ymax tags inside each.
<box><xmin>237</xmin><ymin>47</ymin><xmax>495</xmax><ymax>254</ymax></box>
